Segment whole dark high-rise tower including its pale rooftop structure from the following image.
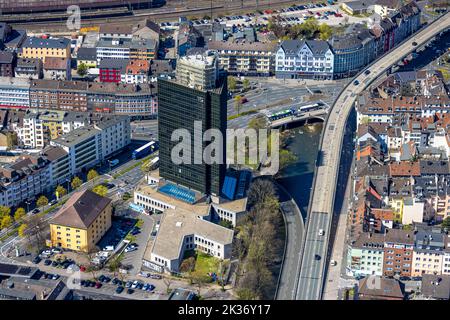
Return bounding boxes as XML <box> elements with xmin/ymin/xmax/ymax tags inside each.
<box><xmin>158</xmin><ymin>51</ymin><xmax>228</xmax><ymax>196</ymax></box>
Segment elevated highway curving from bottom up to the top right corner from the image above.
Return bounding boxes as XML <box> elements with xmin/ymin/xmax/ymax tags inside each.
<box><xmin>296</xmin><ymin>13</ymin><xmax>450</xmax><ymax>300</ymax></box>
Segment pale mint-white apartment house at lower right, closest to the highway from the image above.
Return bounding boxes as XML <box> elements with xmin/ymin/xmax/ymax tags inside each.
<box><xmin>346</xmin><ymin>232</ymin><xmax>384</xmax><ymax>277</ymax></box>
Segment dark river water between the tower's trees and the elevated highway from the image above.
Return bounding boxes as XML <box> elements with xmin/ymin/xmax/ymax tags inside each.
<box><xmin>278</xmin><ymin>123</ymin><xmax>323</xmax><ymax>216</ymax></box>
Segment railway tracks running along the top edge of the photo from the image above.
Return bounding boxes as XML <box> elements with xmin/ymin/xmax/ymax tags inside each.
<box><xmin>7</xmin><ymin>0</ymin><xmax>316</xmax><ymax>32</ymax></box>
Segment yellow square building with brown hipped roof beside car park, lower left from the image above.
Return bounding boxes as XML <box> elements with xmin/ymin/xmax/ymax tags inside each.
<box><xmin>50</xmin><ymin>190</ymin><xmax>112</xmax><ymax>252</ymax></box>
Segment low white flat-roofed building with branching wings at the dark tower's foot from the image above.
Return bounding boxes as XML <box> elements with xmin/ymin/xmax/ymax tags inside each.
<box><xmin>134</xmin><ymin>184</ymin><xmax>240</xmax><ymax>272</ymax></box>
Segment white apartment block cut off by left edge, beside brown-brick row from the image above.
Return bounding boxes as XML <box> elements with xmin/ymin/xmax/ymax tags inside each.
<box><xmin>0</xmin><ymin>77</ymin><xmax>30</xmax><ymax>109</ymax></box>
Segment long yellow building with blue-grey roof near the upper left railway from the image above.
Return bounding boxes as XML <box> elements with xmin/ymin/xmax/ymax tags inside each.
<box><xmin>19</xmin><ymin>37</ymin><xmax>70</xmax><ymax>62</ymax></box>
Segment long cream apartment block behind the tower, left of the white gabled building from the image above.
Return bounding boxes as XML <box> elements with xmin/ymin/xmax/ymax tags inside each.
<box><xmin>208</xmin><ymin>41</ymin><xmax>276</xmax><ymax>76</ymax></box>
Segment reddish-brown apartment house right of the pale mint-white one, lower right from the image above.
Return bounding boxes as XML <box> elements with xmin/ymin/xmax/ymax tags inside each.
<box><xmin>383</xmin><ymin>229</ymin><xmax>414</xmax><ymax>277</ymax></box>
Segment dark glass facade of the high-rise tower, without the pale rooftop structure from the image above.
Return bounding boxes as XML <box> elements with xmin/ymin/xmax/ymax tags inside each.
<box><xmin>158</xmin><ymin>76</ymin><xmax>227</xmax><ymax>196</ymax></box>
